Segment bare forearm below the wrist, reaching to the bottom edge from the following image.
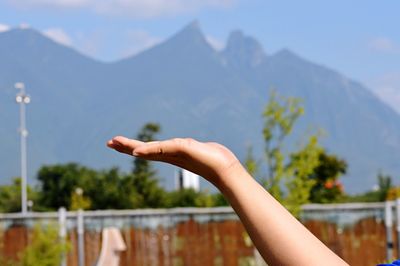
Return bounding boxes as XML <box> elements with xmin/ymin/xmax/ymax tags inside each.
<box><xmin>218</xmin><ymin>165</ymin><xmax>347</xmax><ymax>266</ymax></box>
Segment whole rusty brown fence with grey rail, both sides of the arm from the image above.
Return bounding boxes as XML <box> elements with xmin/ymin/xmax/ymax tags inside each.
<box><xmin>0</xmin><ymin>200</ymin><xmax>400</xmax><ymax>266</ymax></box>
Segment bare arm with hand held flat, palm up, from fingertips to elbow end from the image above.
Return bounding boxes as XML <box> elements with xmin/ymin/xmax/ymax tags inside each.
<box><xmin>107</xmin><ymin>136</ymin><xmax>348</xmax><ymax>266</ymax></box>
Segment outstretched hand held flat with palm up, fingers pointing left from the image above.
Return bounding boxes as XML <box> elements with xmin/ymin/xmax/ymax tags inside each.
<box><xmin>107</xmin><ymin>136</ymin><xmax>241</xmax><ymax>187</ymax></box>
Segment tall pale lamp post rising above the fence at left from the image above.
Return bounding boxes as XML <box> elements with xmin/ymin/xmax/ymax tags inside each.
<box><xmin>14</xmin><ymin>82</ymin><xmax>31</xmax><ymax>214</ymax></box>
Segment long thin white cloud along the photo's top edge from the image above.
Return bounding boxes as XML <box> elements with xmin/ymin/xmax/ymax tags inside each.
<box><xmin>9</xmin><ymin>0</ymin><xmax>237</xmax><ymax>18</ymax></box>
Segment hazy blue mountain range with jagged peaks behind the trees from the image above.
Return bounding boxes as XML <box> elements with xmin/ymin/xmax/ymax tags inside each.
<box><xmin>0</xmin><ymin>22</ymin><xmax>400</xmax><ymax>192</ymax></box>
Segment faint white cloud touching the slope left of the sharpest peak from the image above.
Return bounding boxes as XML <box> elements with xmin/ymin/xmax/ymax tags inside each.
<box><xmin>120</xmin><ymin>30</ymin><xmax>162</xmax><ymax>57</ymax></box>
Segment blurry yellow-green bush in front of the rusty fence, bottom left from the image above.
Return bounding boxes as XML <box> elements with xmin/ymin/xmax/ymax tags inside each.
<box><xmin>19</xmin><ymin>225</ymin><xmax>70</xmax><ymax>266</ymax></box>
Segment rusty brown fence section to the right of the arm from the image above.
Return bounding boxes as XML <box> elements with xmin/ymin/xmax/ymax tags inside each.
<box><xmin>301</xmin><ymin>199</ymin><xmax>400</xmax><ymax>265</ymax></box>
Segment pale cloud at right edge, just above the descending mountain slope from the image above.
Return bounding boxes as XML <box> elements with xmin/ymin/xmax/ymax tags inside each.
<box><xmin>370</xmin><ymin>72</ymin><xmax>400</xmax><ymax>114</ymax></box>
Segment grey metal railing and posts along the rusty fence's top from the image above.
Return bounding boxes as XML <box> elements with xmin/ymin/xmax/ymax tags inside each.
<box><xmin>0</xmin><ymin>199</ymin><xmax>400</xmax><ymax>266</ymax></box>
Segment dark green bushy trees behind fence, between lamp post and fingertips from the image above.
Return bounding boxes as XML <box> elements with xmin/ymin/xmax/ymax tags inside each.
<box><xmin>36</xmin><ymin>163</ymin><xmax>139</xmax><ymax>210</ymax></box>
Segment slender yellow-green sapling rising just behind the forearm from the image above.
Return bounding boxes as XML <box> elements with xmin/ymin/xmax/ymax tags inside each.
<box><xmin>263</xmin><ymin>91</ymin><xmax>322</xmax><ymax>216</ymax></box>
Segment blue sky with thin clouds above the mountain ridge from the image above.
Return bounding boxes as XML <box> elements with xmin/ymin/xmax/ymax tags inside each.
<box><xmin>0</xmin><ymin>0</ymin><xmax>400</xmax><ymax>112</ymax></box>
